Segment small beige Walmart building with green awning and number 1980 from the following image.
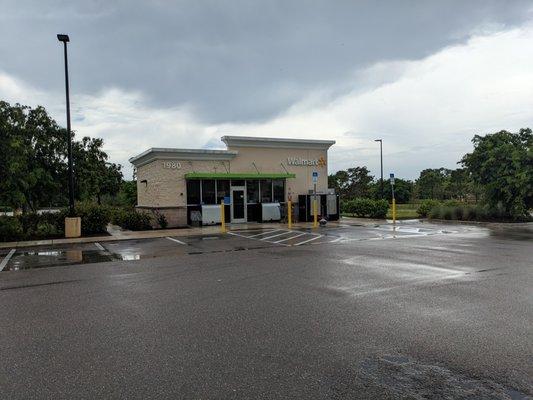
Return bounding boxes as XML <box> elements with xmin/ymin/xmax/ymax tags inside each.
<box><xmin>130</xmin><ymin>136</ymin><xmax>339</xmax><ymax>227</ymax></box>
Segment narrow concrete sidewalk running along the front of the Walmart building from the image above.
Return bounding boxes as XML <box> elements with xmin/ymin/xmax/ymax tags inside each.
<box><xmin>0</xmin><ymin>218</ymin><xmax>370</xmax><ymax>249</ymax></box>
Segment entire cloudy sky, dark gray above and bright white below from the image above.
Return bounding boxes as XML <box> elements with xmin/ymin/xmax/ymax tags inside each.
<box><xmin>0</xmin><ymin>0</ymin><xmax>533</xmax><ymax>178</ymax></box>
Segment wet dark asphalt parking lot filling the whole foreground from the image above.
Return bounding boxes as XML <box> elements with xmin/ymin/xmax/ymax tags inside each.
<box><xmin>0</xmin><ymin>223</ymin><xmax>533</xmax><ymax>399</ymax></box>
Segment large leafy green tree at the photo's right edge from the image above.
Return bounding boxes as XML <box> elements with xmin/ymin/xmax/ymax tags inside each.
<box><xmin>461</xmin><ymin>128</ymin><xmax>533</xmax><ymax>217</ymax></box>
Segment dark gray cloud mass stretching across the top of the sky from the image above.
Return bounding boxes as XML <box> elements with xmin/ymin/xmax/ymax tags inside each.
<box><xmin>0</xmin><ymin>0</ymin><xmax>530</xmax><ymax>124</ymax></box>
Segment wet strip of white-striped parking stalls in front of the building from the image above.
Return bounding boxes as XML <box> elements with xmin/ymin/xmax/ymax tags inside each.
<box><xmin>0</xmin><ymin>221</ymin><xmax>486</xmax><ymax>271</ymax></box>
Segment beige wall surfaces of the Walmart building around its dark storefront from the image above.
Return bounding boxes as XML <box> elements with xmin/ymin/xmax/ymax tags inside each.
<box><xmin>137</xmin><ymin>147</ymin><xmax>328</xmax><ymax>207</ymax></box>
